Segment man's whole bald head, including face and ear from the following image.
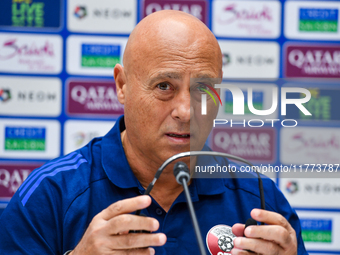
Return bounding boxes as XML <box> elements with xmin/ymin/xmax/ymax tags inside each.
<box><xmin>114</xmin><ymin>11</ymin><xmax>222</xmax><ymax>173</ymax></box>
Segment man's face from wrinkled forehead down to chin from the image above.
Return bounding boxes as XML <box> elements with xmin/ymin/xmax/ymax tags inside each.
<box><xmin>118</xmin><ymin>19</ymin><xmax>222</xmax><ymax>168</ymax></box>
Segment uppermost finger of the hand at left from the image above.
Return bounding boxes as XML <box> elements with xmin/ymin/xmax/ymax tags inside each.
<box><xmin>97</xmin><ymin>195</ymin><xmax>151</xmax><ymax>220</ymax></box>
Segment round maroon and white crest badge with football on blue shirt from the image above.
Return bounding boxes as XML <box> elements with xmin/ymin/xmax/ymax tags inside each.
<box><xmin>206</xmin><ymin>225</ymin><xmax>236</xmax><ymax>255</ymax></box>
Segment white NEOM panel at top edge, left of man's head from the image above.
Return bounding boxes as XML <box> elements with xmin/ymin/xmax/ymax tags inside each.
<box><xmin>67</xmin><ymin>0</ymin><xmax>137</xmax><ymax>34</ymax></box>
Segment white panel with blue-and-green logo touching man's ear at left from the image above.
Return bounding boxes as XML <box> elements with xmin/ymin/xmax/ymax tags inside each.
<box><xmin>66</xmin><ymin>35</ymin><xmax>127</xmax><ymax>77</ymax></box>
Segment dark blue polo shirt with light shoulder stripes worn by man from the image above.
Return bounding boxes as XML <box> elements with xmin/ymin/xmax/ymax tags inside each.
<box><xmin>0</xmin><ymin>117</ymin><xmax>307</xmax><ymax>255</ymax></box>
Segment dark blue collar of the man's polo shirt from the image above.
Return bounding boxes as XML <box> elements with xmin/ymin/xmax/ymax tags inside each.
<box><xmin>102</xmin><ymin>115</ymin><xmax>227</xmax><ymax>195</ymax></box>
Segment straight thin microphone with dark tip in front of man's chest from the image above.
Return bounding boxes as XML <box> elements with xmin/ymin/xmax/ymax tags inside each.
<box><xmin>174</xmin><ymin>162</ymin><xmax>206</xmax><ymax>255</ymax></box>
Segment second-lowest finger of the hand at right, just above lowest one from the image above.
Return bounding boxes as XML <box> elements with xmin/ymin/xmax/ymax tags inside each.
<box><xmin>244</xmin><ymin>225</ymin><xmax>292</xmax><ymax>248</ymax></box>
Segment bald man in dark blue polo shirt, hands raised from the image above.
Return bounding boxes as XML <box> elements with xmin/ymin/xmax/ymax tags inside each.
<box><xmin>0</xmin><ymin>11</ymin><xmax>306</xmax><ymax>255</ymax></box>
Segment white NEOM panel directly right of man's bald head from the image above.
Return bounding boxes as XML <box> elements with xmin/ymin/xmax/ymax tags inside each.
<box><xmin>218</xmin><ymin>40</ymin><xmax>280</xmax><ymax>79</ymax></box>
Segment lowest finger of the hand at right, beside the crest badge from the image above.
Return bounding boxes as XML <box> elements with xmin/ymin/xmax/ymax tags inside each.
<box><xmin>234</xmin><ymin>237</ymin><xmax>284</xmax><ymax>254</ymax></box>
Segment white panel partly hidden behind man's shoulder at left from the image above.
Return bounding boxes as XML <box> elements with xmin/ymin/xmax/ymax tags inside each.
<box><xmin>64</xmin><ymin>120</ymin><xmax>115</xmax><ymax>155</ymax></box>
